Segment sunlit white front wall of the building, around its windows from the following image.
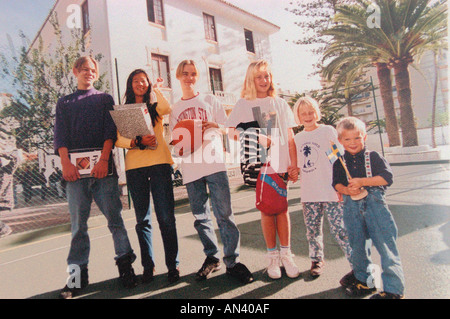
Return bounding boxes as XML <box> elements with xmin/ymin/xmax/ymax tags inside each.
<box><xmin>107</xmin><ymin>0</ymin><xmax>277</xmax><ymax>102</ymax></box>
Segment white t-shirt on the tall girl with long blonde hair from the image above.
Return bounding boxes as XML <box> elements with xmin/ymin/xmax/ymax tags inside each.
<box><xmin>225</xmin><ymin>97</ymin><xmax>297</xmax><ymax>173</ymax></box>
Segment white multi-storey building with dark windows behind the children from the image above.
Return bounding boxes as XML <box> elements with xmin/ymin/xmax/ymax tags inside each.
<box><xmin>32</xmin><ymin>0</ymin><xmax>280</xmax><ymax>108</ymax></box>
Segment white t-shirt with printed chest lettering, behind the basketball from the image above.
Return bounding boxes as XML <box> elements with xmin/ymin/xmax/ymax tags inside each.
<box><xmin>169</xmin><ymin>93</ymin><xmax>227</xmax><ymax>184</ymax></box>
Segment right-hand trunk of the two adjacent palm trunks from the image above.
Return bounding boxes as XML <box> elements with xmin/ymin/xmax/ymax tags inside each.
<box><xmin>394</xmin><ymin>61</ymin><xmax>419</xmax><ymax>146</ymax></box>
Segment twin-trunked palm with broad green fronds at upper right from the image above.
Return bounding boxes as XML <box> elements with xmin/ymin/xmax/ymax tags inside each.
<box><xmin>324</xmin><ymin>0</ymin><xmax>447</xmax><ymax>146</ymax></box>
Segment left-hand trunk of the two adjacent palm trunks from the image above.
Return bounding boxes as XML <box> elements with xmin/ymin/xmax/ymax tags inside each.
<box><xmin>377</xmin><ymin>63</ymin><xmax>401</xmax><ymax>147</ymax></box>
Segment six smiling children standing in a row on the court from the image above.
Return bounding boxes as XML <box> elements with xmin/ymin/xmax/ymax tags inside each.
<box><xmin>55</xmin><ymin>57</ymin><xmax>404</xmax><ymax>298</ymax></box>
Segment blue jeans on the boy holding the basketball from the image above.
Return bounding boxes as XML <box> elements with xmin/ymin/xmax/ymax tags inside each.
<box><xmin>186</xmin><ymin>172</ymin><xmax>240</xmax><ymax>268</ymax></box>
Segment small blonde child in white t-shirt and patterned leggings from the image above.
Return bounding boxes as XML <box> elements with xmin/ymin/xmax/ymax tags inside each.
<box><xmin>293</xmin><ymin>97</ymin><xmax>351</xmax><ymax>283</ymax></box>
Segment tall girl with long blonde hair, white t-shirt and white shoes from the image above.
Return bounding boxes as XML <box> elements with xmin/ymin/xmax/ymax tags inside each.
<box><xmin>225</xmin><ymin>60</ymin><xmax>300</xmax><ymax>279</ymax></box>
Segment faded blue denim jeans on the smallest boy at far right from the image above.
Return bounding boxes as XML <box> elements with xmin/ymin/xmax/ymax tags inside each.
<box><xmin>344</xmin><ymin>187</ymin><xmax>405</xmax><ymax>295</ymax></box>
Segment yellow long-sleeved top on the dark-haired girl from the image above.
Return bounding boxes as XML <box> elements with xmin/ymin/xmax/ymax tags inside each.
<box><xmin>116</xmin><ymin>90</ymin><xmax>173</xmax><ymax>171</ymax></box>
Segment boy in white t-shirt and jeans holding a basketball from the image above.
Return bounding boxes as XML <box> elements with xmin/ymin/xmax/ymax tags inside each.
<box><xmin>170</xmin><ymin>60</ymin><xmax>253</xmax><ymax>283</ymax></box>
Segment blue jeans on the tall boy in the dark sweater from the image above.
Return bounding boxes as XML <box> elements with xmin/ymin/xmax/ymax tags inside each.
<box><xmin>66</xmin><ymin>176</ymin><xmax>136</xmax><ymax>268</ymax></box>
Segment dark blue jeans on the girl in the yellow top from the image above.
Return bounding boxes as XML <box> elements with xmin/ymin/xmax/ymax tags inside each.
<box><xmin>126</xmin><ymin>164</ymin><xmax>179</xmax><ymax>270</ymax></box>
